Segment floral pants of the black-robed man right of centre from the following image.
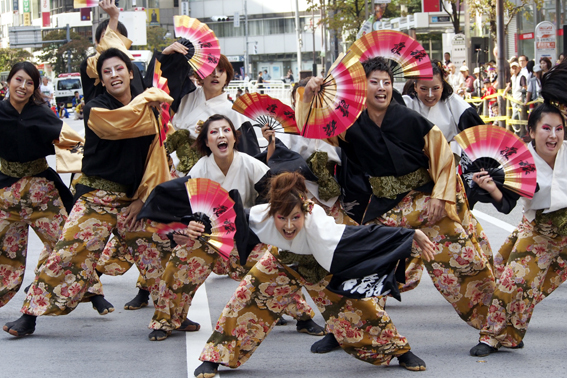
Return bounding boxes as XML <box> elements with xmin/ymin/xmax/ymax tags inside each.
<box><xmin>369</xmin><ymin>191</ymin><xmax>495</xmax><ymax>329</ymax></box>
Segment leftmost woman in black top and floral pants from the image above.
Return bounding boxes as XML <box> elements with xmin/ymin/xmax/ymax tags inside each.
<box><xmin>0</xmin><ymin>62</ymin><xmax>83</xmax><ymax>307</ymax></box>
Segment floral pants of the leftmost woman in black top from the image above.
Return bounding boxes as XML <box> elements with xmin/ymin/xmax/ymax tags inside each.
<box><xmin>0</xmin><ymin>177</ymin><xmax>67</xmax><ymax>307</ymax></box>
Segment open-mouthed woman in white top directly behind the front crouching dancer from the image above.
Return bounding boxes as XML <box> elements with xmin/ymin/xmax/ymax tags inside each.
<box><xmin>146</xmin><ymin>114</ymin><xmax>324</xmax><ymax>341</ymax></box>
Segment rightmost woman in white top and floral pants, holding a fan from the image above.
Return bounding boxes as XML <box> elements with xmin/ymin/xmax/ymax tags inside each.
<box><xmin>470</xmin><ymin>77</ymin><xmax>567</xmax><ymax>356</ymax></box>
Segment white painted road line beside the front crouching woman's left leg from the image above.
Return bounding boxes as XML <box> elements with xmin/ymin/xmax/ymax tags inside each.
<box><xmin>185</xmin><ymin>282</ymin><xmax>220</xmax><ymax>378</ymax></box>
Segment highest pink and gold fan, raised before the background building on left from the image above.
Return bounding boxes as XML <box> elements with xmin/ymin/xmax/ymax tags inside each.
<box><xmin>173</xmin><ymin>16</ymin><xmax>221</xmax><ymax>79</ymax></box>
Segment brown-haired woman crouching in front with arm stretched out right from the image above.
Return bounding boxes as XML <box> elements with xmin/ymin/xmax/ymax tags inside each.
<box><xmin>193</xmin><ymin>172</ymin><xmax>434</xmax><ymax>378</ymax></box>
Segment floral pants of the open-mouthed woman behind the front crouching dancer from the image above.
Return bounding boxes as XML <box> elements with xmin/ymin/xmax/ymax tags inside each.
<box><xmin>149</xmin><ymin>240</ymin><xmax>315</xmax><ymax>331</ymax></box>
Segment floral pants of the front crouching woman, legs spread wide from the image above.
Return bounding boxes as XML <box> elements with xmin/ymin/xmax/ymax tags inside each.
<box><xmin>199</xmin><ymin>248</ymin><xmax>410</xmax><ymax>368</ymax></box>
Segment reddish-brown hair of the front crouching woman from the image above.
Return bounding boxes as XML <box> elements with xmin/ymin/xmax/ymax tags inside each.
<box><xmin>268</xmin><ymin>172</ymin><xmax>307</xmax><ymax>216</ymax></box>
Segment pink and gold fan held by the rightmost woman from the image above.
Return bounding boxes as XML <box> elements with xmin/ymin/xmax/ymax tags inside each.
<box><xmin>455</xmin><ymin>125</ymin><xmax>537</xmax><ymax>198</ymax></box>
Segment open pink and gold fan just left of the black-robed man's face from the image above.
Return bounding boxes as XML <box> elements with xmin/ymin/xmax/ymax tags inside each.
<box><xmin>300</xmin><ymin>52</ymin><xmax>366</xmax><ymax>139</ymax></box>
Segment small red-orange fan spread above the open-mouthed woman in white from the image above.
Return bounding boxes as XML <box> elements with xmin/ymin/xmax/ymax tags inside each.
<box><xmin>232</xmin><ymin>93</ymin><xmax>299</xmax><ymax>135</ymax></box>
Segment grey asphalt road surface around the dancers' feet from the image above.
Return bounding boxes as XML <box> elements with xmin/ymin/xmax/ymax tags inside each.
<box><xmin>0</xmin><ymin>116</ymin><xmax>567</xmax><ymax>378</ymax></box>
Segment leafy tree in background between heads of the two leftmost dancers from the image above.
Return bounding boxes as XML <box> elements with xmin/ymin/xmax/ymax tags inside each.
<box><xmin>40</xmin><ymin>30</ymin><xmax>92</xmax><ymax>75</ymax></box>
